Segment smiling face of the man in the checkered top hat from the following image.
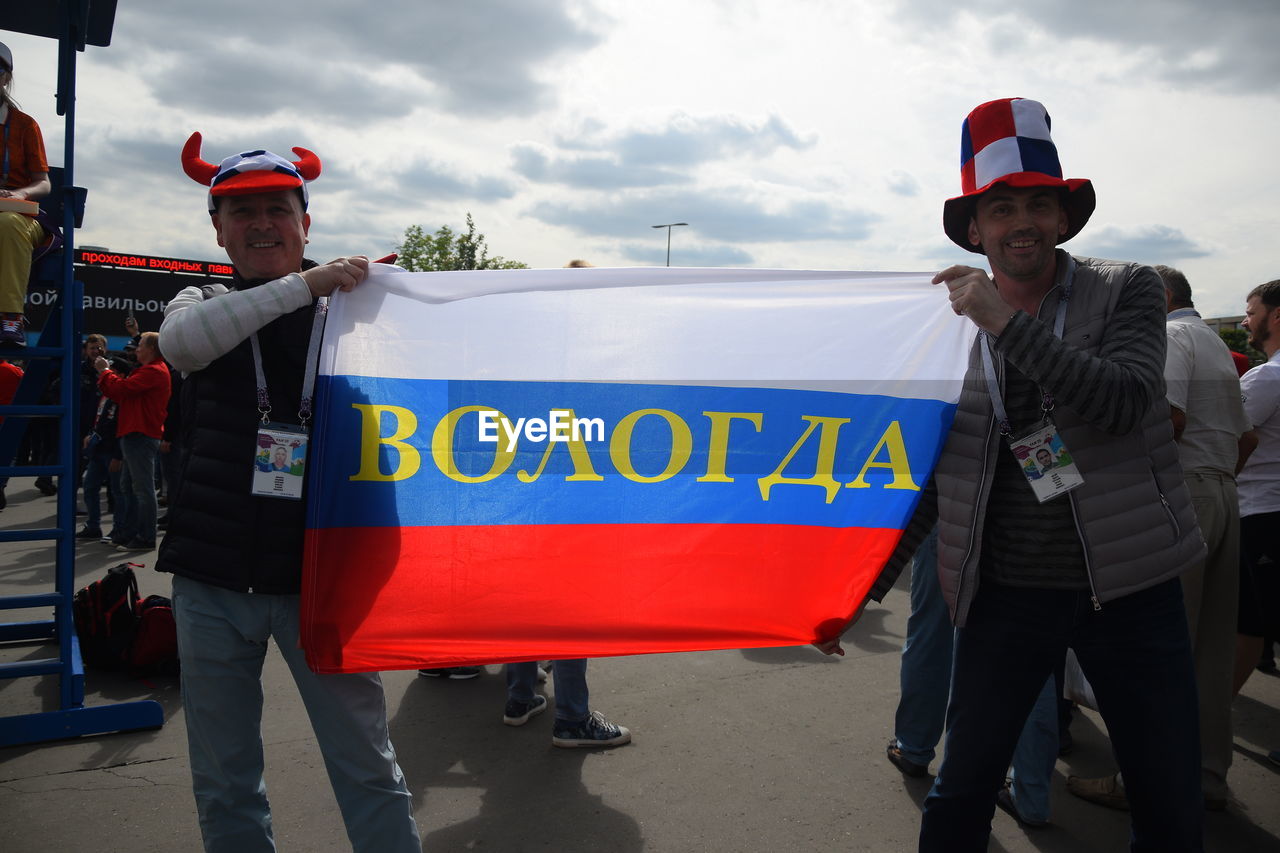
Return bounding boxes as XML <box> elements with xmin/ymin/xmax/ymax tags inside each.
<box><xmin>969</xmin><ymin>184</ymin><xmax>1068</xmax><ymax>280</ymax></box>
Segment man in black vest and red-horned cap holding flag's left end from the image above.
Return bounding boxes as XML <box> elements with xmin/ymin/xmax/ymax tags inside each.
<box><xmin>156</xmin><ymin>133</ymin><xmax>421</xmax><ymax>853</ymax></box>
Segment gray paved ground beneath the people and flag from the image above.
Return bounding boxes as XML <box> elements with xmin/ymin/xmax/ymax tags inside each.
<box><xmin>0</xmin><ymin>478</ymin><xmax>1280</xmax><ymax>853</ymax></box>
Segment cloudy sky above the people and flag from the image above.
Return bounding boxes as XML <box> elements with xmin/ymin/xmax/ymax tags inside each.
<box><xmin>0</xmin><ymin>0</ymin><xmax>1280</xmax><ymax>315</ymax></box>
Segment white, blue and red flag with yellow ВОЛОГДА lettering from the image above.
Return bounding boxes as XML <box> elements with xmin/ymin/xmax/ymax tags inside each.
<box><xmin>302</xmin><ymin>266</ymin><xmax>973</xmax><ymax>672</ymax></box>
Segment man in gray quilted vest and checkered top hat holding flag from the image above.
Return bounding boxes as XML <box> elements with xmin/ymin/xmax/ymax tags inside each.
<box><xmin>828</xmin><ymin>99</ymin><xmax>1204</xmax><ymax>852</ymax></box>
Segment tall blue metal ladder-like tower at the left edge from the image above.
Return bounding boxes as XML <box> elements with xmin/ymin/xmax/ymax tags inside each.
<box><xmin>0</xmin><ymin>0</ymin><xmax>164</xmax><ymax>745</ymax></box>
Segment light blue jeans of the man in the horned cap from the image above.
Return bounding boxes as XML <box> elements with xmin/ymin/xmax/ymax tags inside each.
<box><xmin>173</xmin><ymin>576</ymin><xmax>422</xmax><ymax>853</ymax></box>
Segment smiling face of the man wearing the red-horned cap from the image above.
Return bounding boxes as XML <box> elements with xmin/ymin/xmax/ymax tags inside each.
<box><xmin>212</xmin><ymin>190</ymin><xmax>311</xmax><ymax>279</ymax></box>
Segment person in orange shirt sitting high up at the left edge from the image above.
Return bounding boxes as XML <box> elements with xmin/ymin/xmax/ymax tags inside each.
<box><xmin>0</xmin><ymin>42</ymin><xmax>51</xmax><ymax>346</ymax></box>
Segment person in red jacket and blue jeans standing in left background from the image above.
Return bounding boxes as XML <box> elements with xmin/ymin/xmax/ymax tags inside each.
<box><xmin>93</xmin><ymin>332</ymin><xmax>170</xmax><ymax>551</ymax></box>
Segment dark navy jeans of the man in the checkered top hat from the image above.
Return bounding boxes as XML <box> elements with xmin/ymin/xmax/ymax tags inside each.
<box><xmin>920</xmin><ymin>579</ymin><xmax>1204</xmax><ymax>853</ymax></box>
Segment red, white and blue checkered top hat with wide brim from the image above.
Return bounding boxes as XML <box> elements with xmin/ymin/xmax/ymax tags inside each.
<box><xmin>942</xmin><ymin>97</ymin><xmax>1097</xmax><ymax>255</ymax></box>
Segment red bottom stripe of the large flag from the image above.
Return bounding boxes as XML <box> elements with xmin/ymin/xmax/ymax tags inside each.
<box><xmin>302</xmin><ymin>524</ymin><xmax>901</xmax><ymax>672</ymax></box>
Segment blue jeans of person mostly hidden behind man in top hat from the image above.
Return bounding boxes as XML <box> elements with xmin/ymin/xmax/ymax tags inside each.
<box><xmin>893</xmin><ymin>528</ymin><xmax>1057</xmax><ymax>821</ymax></box>
